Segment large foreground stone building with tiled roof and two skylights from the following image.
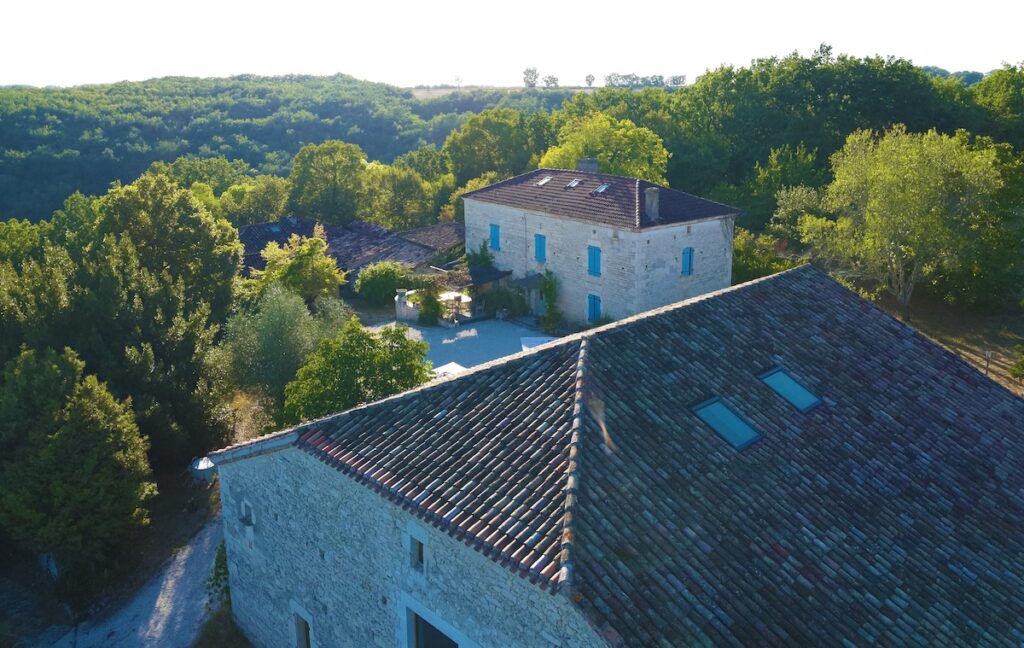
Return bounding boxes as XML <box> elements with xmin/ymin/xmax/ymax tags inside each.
<box><xmin>211</xmin><ymin>266</ymin><xmax>1024</xmax><ymax>648</ymax></box>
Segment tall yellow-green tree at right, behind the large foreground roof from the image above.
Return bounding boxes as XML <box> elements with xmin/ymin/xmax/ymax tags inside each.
<box><xmin>800</xmin><ymin>126</ymin><xmax>1002</xmax><ymax>318</ymax></box>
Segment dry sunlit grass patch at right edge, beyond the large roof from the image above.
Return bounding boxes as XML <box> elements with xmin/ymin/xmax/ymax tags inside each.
<box><xmin>880</xmin><ymin>295</ymin><xmax>1024</xmax><ymax>396</ymax></box>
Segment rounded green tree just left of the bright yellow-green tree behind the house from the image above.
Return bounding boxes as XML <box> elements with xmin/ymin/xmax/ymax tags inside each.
<box><xmin>443</xmin><ymin>109</ymin><xmax>534</xmax><ymax>184</ymax></box>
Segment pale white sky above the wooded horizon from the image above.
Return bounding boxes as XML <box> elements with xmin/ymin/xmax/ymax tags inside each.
<box><xmin>0</xmin><ymin>0</ymin><xmax>1024</xmax><ymax>86</ymax></box>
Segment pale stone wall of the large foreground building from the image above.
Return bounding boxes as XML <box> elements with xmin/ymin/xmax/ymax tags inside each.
<box><xmin>219</xmin><ymin>446</ymin><xmax>607</xmax><ymax>648</ymax></box>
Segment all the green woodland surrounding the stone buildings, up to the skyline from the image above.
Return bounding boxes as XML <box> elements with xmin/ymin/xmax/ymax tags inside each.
<box><xmin>0</xmin><ymin>47</ymin><xmax>1024</xmax><ymax>601</ymax></box>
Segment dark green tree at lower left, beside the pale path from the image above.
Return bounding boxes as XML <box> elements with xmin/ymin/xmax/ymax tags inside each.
<box><xmin>0</xmin><ymin>349</ymin><xmax>156</xmax><ymax>593</ymax></box>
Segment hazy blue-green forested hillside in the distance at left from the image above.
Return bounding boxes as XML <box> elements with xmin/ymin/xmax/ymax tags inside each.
<box><xmin>0</xmin><ymin>75</ymin><xmax>571</xmax><ymax>220</ymax></box>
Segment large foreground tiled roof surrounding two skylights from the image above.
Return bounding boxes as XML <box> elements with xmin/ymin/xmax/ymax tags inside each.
<box><xmin>214</xmin><ymin>266</ymin><xmax>1024</xmax><ymax>645</ymax></box>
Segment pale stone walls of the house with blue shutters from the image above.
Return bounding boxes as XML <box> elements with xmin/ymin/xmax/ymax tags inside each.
<box><xmin>464</xmin><ymin>199</ymin><xmax>733</xmax><ymax>322</ymax></box>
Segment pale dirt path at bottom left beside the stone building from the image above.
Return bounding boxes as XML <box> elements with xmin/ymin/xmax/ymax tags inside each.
<box><xmin>43</xmin><ymin>516</ymin><xmax>222</xmax><ymax>648</ymax></box>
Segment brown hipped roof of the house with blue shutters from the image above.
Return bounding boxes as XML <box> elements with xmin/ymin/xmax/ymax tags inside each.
<box><xmin>463</xmin><ymin>169</ymin><xmax>739</xmax><ymax>229</ymax></box>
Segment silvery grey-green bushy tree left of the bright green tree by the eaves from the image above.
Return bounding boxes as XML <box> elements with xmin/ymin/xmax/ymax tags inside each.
<box><xmin>216</xmin><ymin>286</ymin><xmax>346</xmax><ymax>406</ymax></box>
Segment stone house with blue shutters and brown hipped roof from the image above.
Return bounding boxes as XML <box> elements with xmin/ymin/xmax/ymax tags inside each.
<box><xmin>463</xmin><ymin>161</ymin><xmax>739</xmax><ymax>322</ymax></box>
